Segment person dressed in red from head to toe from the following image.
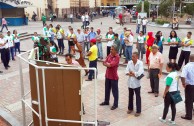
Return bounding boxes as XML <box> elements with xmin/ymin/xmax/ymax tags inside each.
<box><xmin>146</xmin><ymin>32</ymin><xmax>155</xmax><ymax>64</ymax></box>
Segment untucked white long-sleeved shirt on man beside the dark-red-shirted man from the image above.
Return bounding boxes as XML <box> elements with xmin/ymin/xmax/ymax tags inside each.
<box><xmin>125</xmin><ymin>60</ymin><xmax>144</xmax><ymax>89</ymax></box>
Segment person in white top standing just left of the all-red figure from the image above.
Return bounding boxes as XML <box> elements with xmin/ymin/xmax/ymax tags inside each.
<box><xmin>136</xmin><ymin>31</ymin><xmax>146</xmax><ymax>60</ymax></box>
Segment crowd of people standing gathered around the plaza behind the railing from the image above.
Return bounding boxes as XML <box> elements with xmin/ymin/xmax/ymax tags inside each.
<box><xmin>0</xmin><ymin>15</ymin><xmax>194</xmax><ymax>124</ymax></box>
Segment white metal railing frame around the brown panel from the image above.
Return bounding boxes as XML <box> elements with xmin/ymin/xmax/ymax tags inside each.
<box><xmin>18</xmin><ymin>48</ymin><xmax>98</xmax><ymax>126</ymax></box>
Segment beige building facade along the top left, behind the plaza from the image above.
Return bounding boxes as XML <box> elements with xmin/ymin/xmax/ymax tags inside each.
<box><xmin>25</xmin><ymin>0</ymin><xmax>101</xmax><ymax>19</ymax></box>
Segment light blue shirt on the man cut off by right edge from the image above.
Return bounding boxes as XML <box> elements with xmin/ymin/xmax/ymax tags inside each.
<box><xmin>181</xmin><ymin>62</ymin><xmax>194</xmax><ymax>85</ymax></box>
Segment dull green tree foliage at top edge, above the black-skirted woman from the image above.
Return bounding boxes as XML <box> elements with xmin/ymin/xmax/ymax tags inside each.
<box><xmin>159</xmin><ymin>0</ymin><xmax>173</xmax><ymax>18</ymax></box>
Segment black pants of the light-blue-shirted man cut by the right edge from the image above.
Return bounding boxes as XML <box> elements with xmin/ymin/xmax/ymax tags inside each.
<box><xmin>185</xmin><ymin>85</ymin><xmax>194</xmax><ymax>119</ymax></box>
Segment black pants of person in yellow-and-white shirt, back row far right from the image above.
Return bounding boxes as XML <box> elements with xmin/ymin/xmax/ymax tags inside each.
<box><xmin>178</xmin><ymin>51</ymin><xmax>191</xmax><ymax>68</ymax></box>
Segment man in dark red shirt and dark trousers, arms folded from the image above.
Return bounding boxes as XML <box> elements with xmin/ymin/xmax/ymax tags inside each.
<box><xmin>100</xmin><ymin>45</ymin><xmax>120</xmax><ymax>110</ymax></box>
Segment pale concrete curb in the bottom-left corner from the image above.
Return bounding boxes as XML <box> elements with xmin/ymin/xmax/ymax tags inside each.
<box><xmin>0</xmin><ymin>108</ymin><xmax>22</xmax><ymax>126</ymax></box>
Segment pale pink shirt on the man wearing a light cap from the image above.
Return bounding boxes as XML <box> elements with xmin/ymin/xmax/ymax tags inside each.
<box><xmin>149</xmin><ymin>52</ymin><xmax>164</xmax><ymax>69</ymax></box>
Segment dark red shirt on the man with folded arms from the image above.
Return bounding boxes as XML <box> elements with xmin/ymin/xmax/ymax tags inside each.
<box><xmin>104</xmin><ymin>54</ymin><xmax>120</xmax><ymax>80</ymax></box>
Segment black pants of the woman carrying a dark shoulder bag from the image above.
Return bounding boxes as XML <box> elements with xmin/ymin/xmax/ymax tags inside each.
<box><xmin>162</xmin><ymin>91</ymin><xmax>176</xmax><ymax>121</ymax></box>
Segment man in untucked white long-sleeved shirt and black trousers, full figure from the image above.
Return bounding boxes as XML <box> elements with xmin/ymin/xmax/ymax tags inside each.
<box><xmin>125</xmin><ymin>52</ymin><xmax>144</xmax><ymax>117</ymax></box>
